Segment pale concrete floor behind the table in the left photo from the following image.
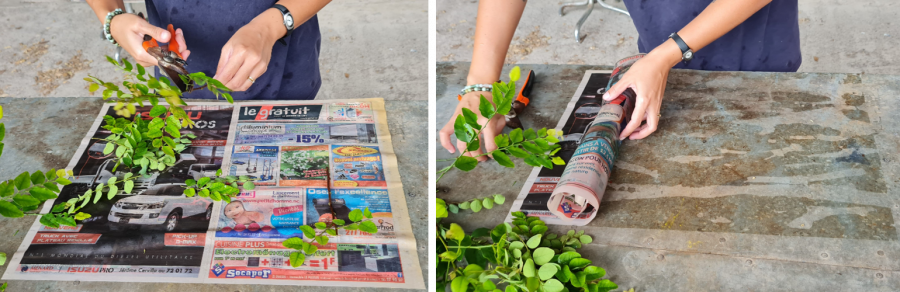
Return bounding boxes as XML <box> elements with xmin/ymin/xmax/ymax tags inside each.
<box><xmin>0</xmin><ymin>0</ymin><xmax>430</xmax><ymax>100</ymax></box>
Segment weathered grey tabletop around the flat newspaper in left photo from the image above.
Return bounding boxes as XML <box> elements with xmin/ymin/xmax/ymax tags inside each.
<box><xmin>0</xmin><ymin>97</ymin><xmax>431</xmax><ymax>292</ymax></box>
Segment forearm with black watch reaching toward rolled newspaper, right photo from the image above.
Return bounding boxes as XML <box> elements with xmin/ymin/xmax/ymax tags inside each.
<box><xmin>651</xmin><ymin>0</ymin><xmax>772</xmax><ymax>66</ymax></box>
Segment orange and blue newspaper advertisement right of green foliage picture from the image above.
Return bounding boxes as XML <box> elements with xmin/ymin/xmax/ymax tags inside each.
<box><xmin>331</xmin><ymin>145</ymin><xmax>387</xmax><ymax>188</ymax></box>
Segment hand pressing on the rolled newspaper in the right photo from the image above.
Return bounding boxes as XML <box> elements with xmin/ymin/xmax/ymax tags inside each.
<box><xmin>603</xmin><ymin>50</ymin><xmax>673</xmax><ymax>140</ymax></box>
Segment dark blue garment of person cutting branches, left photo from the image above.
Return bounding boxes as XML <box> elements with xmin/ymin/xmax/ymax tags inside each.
<box><xmin>146</xmin><ymin>0</ymin><xmax>322</xmax><ymax>100</ymax></box>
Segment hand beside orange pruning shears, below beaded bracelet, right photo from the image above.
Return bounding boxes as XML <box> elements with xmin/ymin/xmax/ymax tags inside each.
<box><xmin>439</xmin><ymin>91</ymin><xmax>506</xmax><ymax>161</ymax></box>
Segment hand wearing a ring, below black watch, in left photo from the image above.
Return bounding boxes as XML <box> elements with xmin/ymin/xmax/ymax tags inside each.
<box><xmin>213</xmin><ymin>19</ymin><xmax>278</xmax><ymax>91</ymax></box>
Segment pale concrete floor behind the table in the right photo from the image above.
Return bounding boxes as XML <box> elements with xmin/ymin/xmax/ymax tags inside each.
<box><xmin>434</xmin><ymin>0</ymin><xmax>900</xmax><ymax>74</ymax></box>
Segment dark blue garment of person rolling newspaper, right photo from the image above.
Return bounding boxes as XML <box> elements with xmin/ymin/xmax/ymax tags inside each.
<box><xmin>625</xmin><ymin>0</ymin><xmax>801</xmax><ymax>72</ymax></box>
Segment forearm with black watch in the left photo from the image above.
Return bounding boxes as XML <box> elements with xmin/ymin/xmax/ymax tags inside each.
<box><xmin>250</xmin><ymin>0</ymin><xmax>331</xmax><ymax>40</ymax></box>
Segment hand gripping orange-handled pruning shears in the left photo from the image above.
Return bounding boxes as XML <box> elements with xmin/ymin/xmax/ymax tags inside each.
<box><xmin>109</xmin><ymin>13</ymin><xmax>191</xmax><ymax>67</ymax></box>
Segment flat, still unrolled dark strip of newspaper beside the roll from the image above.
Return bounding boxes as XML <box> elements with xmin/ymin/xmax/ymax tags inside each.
<box><xmin>506</xmin><ymin>70</ymin><xmax>611</xmax><ymax>225</ymax></box>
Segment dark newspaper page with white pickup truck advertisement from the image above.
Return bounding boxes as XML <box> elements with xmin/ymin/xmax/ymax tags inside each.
<box><xmin>12</xmin><ymin>106</ymin><xmax>233</xmax><ymax>277</ymax></box>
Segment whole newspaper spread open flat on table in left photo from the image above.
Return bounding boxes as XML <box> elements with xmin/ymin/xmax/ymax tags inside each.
<box><xmin>3</xmin><ymin>98</ymin><xmax>425</xmax><ymax>289</ymax></box>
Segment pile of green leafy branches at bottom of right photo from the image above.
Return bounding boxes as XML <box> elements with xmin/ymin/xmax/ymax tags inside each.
<box><xmin>434</xmin><ymin>212</ymin><xmax>618</xmax><ymax>292</ymax></box>
